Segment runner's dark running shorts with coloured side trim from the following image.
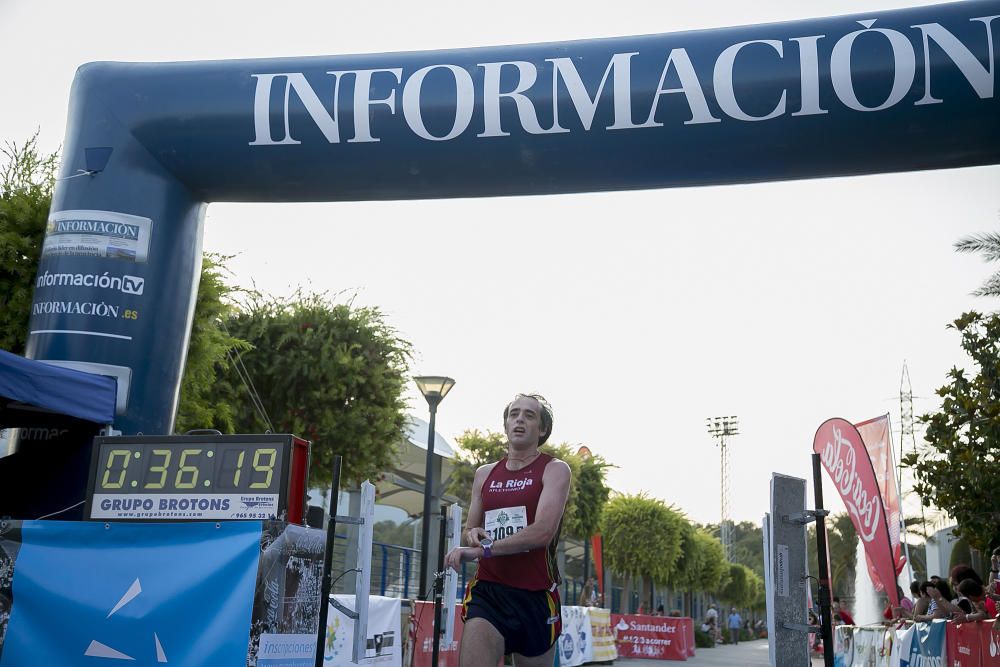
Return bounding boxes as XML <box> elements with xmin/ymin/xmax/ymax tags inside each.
<box><xmin>462</xmin><ymin>579</ymin><xmax>562</xmax><ymax>658</ymax></box>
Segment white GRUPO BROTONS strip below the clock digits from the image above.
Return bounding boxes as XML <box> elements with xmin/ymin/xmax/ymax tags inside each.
<box><xmin>90</xmin><ymin>493</ymin><xmax>278</xmax><ymax>520</ymax></box>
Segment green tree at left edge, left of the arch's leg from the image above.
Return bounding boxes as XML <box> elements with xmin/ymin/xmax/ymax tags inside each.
<box><xmin>0</xmin><ymin>132</ymin><xmax>59</xmax><ymax>354</ymax></box>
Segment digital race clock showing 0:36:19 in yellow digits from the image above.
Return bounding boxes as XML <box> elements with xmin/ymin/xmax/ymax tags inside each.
<box><xmin>84</xmin><ymin>435</ymin><xmax>309</xmax><ymax>523</ymax></box>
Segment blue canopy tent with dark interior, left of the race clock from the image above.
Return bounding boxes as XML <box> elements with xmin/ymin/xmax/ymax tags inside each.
<box><xmin>0</xmin><ymin>350</ymin><xmax>117</xmax><ymax>519</ymax></box>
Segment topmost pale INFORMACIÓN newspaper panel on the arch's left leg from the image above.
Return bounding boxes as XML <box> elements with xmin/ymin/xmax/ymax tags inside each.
<box><xmin>42</xmin><ymin>211</ymin><xmax>153</xmax><ymax>263</ymax></box>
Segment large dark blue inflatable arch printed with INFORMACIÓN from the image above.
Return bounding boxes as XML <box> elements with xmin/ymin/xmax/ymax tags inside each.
<box><xmin>28</xmin><ymin>0</ymin><xmax>1000</xmax><ymax>433</ymax></box>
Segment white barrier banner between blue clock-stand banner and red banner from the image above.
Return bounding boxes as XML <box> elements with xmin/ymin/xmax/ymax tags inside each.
<box><xmin>320</xmin><ymin>595</ymin><xmax>403</xmax><ymax>667</ymax></box>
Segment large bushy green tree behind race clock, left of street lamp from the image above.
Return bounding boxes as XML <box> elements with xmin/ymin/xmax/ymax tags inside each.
<box><xmin>218</xmin><ymin>292</ymin><xmax>411</xmax><ymax>487</ymax></box>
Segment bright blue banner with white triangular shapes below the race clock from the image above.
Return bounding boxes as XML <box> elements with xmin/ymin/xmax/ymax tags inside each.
<box><xmin>0</xmin><ymin>521</ymin><xmax>261</xmax><ymax>667</ymax></box>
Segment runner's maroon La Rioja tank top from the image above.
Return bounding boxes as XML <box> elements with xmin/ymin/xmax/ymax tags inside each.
<box><xmin>476</xmin><ymin>454</ymin><xmax>562</xmax><ymax>591</ymax></box>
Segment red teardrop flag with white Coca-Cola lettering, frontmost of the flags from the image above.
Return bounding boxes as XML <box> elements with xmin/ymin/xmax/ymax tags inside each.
<box><xmin>813</xmin><ymin>418</ymin><xmax>899</xmax><ymax>607</ymax></box>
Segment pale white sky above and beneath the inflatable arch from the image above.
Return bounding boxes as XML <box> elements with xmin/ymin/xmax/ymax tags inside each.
<box><xmin>0</xmin><ymin>0</ymin><xmax>1000</xmax><ymax>522</ymax></box>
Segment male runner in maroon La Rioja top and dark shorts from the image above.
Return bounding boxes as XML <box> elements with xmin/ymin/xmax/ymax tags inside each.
<box><xmin>445</xmin><ymin>394</ymin><xmax>570</xmax><ymax>667</ymax></box>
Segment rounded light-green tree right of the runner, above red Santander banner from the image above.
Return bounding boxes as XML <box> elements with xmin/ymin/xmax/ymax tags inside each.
<box><xmin>601</xmin><ymin>493</ymin><xmax>687</xmax><ymax>604</ymax></box>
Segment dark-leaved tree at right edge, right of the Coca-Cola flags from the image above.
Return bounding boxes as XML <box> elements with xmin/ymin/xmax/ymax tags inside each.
<box><xmin>903</xmin><ymin>312</ymin><xmax>1000</xmax><ymax>551</ymax></box>
